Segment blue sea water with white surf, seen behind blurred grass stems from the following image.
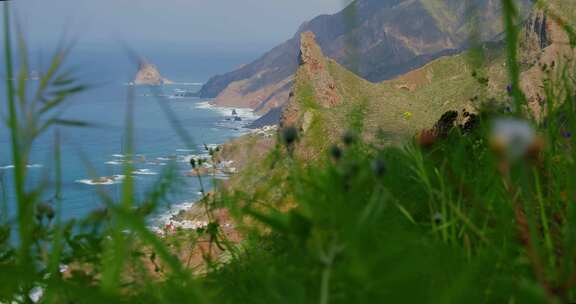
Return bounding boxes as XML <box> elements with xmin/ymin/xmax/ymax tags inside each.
<box><xmin>0</xmin><ymin>47</ymin><xmax>255</xmax><ymax>227</ymax></box>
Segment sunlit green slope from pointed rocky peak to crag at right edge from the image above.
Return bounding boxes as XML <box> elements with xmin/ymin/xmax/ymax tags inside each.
<box><xmin>220</xmin><ymin>2</ymin><xmax>575</xmax><ymax>211</ymax></box>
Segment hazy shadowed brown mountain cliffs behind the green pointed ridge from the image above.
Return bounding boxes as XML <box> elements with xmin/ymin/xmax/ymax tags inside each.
<box><xmin>201</xmin><ymin>0</ymin><xmax>530</xmax><ymax>112</ymax></box>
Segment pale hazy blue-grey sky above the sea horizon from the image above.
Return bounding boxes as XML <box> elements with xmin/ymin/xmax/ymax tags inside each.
<box><xmin>12</xmin><ymin>0</ymin><xmax>349</xmax><ymax>51</ymax></box>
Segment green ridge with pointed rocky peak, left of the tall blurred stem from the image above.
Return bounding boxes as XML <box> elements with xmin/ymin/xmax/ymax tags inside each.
<box><xmin>218</xmin><ymin>32</ymin><xmax>509</xmax><ymax>204</ymax></box>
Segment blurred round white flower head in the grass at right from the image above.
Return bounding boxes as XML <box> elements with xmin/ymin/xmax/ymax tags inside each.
<box><xmin>491</xmin><ymin>118</ymin><xmax>537</xmax><ymax>159</ymax></box>
